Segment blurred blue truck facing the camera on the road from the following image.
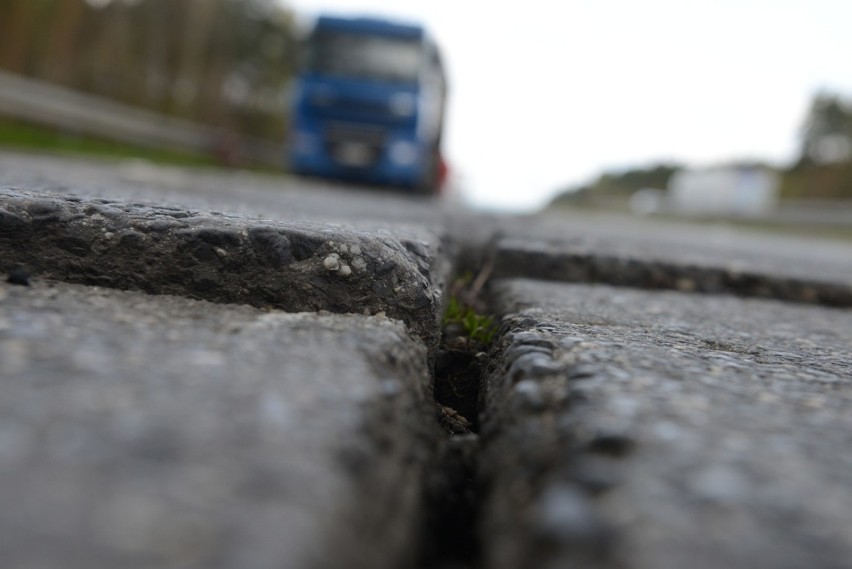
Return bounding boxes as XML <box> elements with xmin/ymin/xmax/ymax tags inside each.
<box><xmin>288</xmin><ymin>15</ymin><xmax>447</xmax><ymax>193</ymax></box>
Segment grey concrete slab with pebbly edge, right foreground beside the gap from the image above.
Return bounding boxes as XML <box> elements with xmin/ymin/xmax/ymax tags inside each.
<box><xmin>480</xmin><ymin>279</ymin><xmax>852</xmax><ymax>569</ymax></box>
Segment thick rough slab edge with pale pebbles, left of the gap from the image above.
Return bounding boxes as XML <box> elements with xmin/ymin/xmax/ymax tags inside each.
<box><xmin>0</xmin><ymin>188</ymin><xmax>448</xmax><ymax>347</ymax></box>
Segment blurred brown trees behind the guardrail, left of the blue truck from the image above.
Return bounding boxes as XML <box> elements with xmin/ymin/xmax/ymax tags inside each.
<box><xmin>0</xmin><ymin>0</ymin><xmax>296</xmax><ymax>140</ymax></box>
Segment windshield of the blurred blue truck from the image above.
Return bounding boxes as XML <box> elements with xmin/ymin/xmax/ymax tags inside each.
<box><xmin>307</xmin><ymin>30</ymin><xmax>422</xmax><ymax>83</ymax></box>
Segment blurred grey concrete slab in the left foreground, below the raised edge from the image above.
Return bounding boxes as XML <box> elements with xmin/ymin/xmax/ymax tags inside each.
<box><xmin>0</xmin><ymin>280</ymin><xmax>440</xmax><ymax>569</ymax></box>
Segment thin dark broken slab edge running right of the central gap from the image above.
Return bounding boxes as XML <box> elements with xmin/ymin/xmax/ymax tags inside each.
<box><xmin>492</xmin><ymin>239</ymin><xmax>852</xmax><ymax>307</ymax></box>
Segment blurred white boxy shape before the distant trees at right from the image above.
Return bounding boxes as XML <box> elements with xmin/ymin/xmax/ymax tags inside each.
<box><xmin>666</xmin><ymin>166</ymin><xmax>780</xmax><ymax>216</ymax></box>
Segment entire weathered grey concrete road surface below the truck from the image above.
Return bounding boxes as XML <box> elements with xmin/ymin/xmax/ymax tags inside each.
<box><xmin>5</xmin><ymin>153</ymin><xmax>852</xmax><ymax>568</ymax></box>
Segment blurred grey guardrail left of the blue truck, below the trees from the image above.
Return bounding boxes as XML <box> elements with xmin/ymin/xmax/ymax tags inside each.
<box><xmin>0</xmin><ymin>71</ymin><xmax>283</xmax><ymax>166</ymax></box>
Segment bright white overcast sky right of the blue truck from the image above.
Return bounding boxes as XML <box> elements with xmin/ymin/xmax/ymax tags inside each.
<box><xmin>283</xmin><ymin>0</ymin><xmax>852</xmax><ymax>210</ymax></box>
